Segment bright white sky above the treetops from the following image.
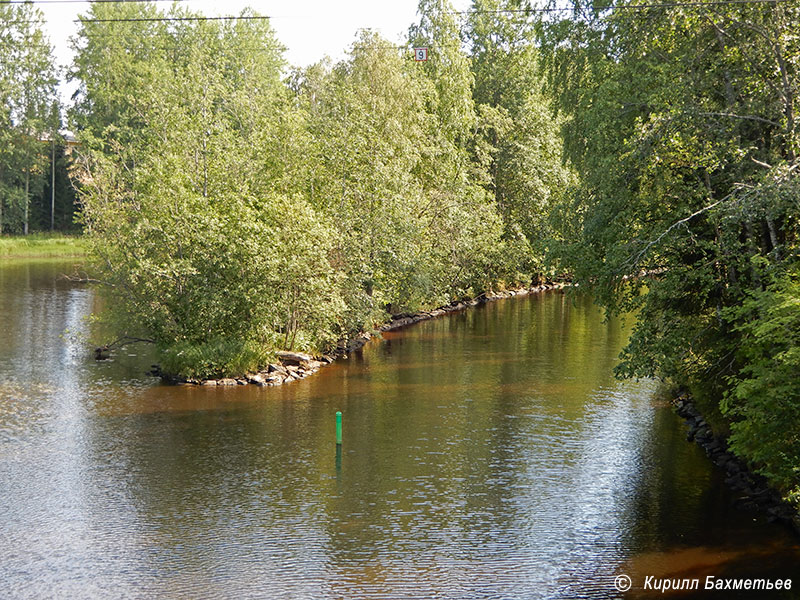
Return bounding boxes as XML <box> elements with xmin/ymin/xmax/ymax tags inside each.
<box><xmin>36</xmin><ymin>0</ymin><xmax>471</xmax><ymax>106</ymax></box>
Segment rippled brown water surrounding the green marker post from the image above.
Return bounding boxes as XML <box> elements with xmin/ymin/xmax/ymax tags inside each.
<box><xmin>0</xmin><ymin>261</ymin><xmax>800</xmax><ymax>599</ymax></box>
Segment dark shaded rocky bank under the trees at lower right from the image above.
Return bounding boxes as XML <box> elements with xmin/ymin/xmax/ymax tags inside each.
<box><xmin>672</xmin><ymin>393</ymin><xmax>800</xmax><ymax>534</ymax></box>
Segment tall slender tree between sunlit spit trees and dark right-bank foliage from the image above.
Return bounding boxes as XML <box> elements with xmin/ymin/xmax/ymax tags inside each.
<box><xmin>465</xmin><ymin>0</ymin><xmax>573</xmax><ymax>273</ymax></box>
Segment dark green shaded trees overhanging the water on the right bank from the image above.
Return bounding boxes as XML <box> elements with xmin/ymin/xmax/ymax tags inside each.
<box><xmin>542</xmin><ymin>1</ymin><xmax>800</xmax><ymax>502</ymax></box>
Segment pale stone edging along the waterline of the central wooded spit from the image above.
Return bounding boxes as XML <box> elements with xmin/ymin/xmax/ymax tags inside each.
<box><xmin>156</xmin><ymin>282</ymin><xmax>569</xmax><ymax>387</ymax></box>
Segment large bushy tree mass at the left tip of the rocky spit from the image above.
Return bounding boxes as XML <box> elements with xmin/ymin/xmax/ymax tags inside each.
<box><xmin>73</xmin><ymin>5</ymin><xmax>341</xmax><ymax>376</ymax></box>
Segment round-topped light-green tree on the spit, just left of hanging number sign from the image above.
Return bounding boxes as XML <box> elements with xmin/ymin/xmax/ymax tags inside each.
<box><xmin>306</xmin><ymin>32</ymin><xmax>438</xmax><ymax>329</ymax></box>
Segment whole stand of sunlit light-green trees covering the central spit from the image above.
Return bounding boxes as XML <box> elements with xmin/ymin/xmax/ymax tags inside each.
<box><xmin>71</xmin><ymin>0</ymin><xmax>563</xmax><ymax>377</ymax></box>
